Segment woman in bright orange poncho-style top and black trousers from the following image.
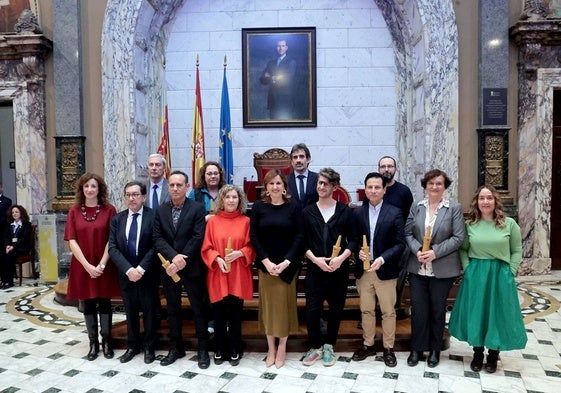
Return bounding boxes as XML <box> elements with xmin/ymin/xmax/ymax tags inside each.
<box><xmin>201</xmin><ymin>184</ymin><xmax>255</xmax><ymax>366</ymax></box>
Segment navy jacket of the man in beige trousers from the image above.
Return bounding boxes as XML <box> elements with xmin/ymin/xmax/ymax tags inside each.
<box><xmin>354</xmin><ymin>201</ymin><xmax>405</xmax><ymax>280</ymax></box>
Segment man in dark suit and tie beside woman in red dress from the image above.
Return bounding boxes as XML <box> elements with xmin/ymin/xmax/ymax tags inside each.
<box><xmin>109</xmin><ymin>181</ymin><xmax>159</xmax><ymax>364</ymax></box>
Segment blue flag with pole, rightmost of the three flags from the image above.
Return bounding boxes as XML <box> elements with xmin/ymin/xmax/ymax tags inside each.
<box><xmin>218</xmin><ymin>56</ymin><xmax>234</xmax><ymax>184</ymax></box>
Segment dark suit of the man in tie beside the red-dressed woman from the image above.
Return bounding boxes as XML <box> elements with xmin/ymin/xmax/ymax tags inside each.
<box><xmin>109</xmin><ymin>207</ymin><xmax>159</xmax><ymax>351</ymax></box>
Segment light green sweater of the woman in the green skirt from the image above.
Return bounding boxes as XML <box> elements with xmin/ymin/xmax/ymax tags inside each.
<box><xmin>460</xmin><ymin>217</ymin><xmax>522</xmax><ymax>275</ymax></box>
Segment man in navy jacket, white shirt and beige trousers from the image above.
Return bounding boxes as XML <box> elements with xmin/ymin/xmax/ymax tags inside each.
<box><xmin>352</xmin><ymin>172</ymin><xmax>405</xmax><ymax>367</ymax></box>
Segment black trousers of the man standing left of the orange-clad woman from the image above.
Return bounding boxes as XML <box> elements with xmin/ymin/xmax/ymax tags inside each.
<box><xmin>162</xmin><ymin>274</ymin><xmax>208</xmax><ymax>351</ymax></box>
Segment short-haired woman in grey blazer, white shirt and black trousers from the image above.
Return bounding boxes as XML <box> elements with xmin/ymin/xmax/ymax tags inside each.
<box><xmin>405</xmin><ymin>169</ymin><xmax>465</xmax><ymax>368</ymax></box>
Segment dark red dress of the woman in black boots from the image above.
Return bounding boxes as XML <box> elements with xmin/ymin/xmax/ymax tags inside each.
<box><xmin>64</xmin><ymin>204</ymin><xmax>121</xmax><ymax>299</ymax></box>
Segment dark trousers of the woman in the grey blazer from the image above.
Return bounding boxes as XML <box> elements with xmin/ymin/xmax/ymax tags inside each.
<box><xmin>409</xmin><ymin>274</ymin><xmax>456</xmax><ymax>351</ymax></box>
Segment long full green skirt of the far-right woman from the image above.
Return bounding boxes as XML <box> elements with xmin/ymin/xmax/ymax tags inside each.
<box><xmin>448</xmin><ymin>259</ymin><xmax>528</xmax><ymax>351</ymax></box>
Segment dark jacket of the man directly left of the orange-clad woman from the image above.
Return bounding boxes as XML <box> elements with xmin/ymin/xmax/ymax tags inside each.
<box><xmin>153</xmin><ymin>198</ymin><xmax>206</xmax><ymax>278</ymax></box>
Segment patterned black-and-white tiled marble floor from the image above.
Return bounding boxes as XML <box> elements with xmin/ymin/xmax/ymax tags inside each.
<box><xmin>0</xmin><ymin>274</ymin><xmax>561</xmax><ymax>393</ymax></box>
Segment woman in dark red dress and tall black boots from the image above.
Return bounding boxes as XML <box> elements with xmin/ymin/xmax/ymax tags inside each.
<box><xmin>64</xmin><ymin>173</ymin><xmax>121</xmax><ymax>360</ymax></box>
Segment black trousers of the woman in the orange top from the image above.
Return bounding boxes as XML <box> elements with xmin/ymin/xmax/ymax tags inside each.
<box><xmin>212</xmin><ymin>295</ymin><xmax>243</xmax><ymax>356</ymax></box>
